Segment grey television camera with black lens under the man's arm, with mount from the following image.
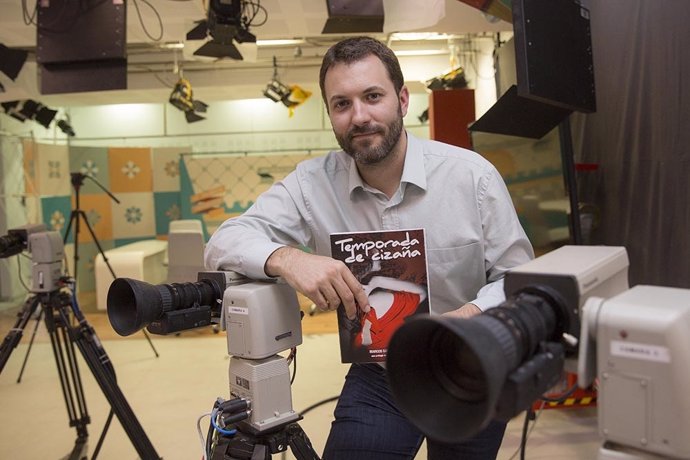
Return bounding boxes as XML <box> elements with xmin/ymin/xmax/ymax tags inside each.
<box><xmin>107</xmin><ymin>271</ymin><xmax>318</xmax><ymax>459</ymax></box>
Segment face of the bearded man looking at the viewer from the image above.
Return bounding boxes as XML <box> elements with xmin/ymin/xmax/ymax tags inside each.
<box><xmin>324</xmin><ymin>55</ymin><xmax>409</xmax><ymax>164</ymax></box>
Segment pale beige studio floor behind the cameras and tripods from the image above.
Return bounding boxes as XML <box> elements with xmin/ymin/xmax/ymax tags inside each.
<box><xmin>0</xmin><ymin>300</ymin><xmax>600</xmax><ymax>460</ymax></box>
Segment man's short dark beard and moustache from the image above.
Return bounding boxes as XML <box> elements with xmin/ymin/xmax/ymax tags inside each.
<box><xmin>335</xmin><ymin>109</ymin><xmax>403</xmax><ymax>165</ymax></box>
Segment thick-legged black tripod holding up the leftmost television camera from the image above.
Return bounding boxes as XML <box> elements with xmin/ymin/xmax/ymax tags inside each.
<box><xmin>0</xmin><ymin>280</ymin><xmax>160</xmax><ymax>460</ymax></box>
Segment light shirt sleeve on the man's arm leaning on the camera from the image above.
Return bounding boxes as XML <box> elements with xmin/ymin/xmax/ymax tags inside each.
<box><xmin>204</xmin><ymin>172</ymin><xmax>310</xmax><ymax>279</ymax></box>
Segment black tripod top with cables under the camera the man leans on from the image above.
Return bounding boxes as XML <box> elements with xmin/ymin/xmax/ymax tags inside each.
<box><xmin>210</xmin><ymin>422</ymin><xmax>320</xmax><ymax>460</ymax></box>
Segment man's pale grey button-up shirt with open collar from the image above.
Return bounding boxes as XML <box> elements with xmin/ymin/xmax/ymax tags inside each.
<box><xmin>205</xmin><ymin>133</ymin><xmax>534</xmax><ymax>313</ymax></box>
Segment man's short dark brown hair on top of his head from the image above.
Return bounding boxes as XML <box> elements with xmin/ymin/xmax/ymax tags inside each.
<box><xmin>319</xmin><ymin>37</ymin><xmax>405</xmax><ymax>107</ymax></box>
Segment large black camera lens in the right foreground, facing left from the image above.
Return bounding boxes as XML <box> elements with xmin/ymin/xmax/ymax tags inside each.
<box><xmin>387</xmin><ymin>288</ymin><xmax>566</xmax><ymax>442</ymax></box>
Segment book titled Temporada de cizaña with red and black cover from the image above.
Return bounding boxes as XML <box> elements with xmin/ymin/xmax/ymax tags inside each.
<box><xmin>330</xmin><ymin>228</ymin><xmax>429</xmax><ymax>363</ymax></box>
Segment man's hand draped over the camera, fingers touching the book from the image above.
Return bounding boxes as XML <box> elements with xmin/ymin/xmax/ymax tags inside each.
<box><xmin>264</xmin><ymin>246</ymin><xmax>369</xmax><ymax>319</ymax></box>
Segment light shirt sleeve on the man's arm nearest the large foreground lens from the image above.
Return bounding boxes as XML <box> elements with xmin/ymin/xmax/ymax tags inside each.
<box><xmin>470</xmin><ymin>167</ymin><xmax>534</xmax><ymax>311</ymax></box>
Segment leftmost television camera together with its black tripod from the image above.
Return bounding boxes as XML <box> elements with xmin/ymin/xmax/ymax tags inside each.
<box><xmin>0</xmin><ymin>224</ymin><xmax>160</xmax><ymax>459</ymax></box>
